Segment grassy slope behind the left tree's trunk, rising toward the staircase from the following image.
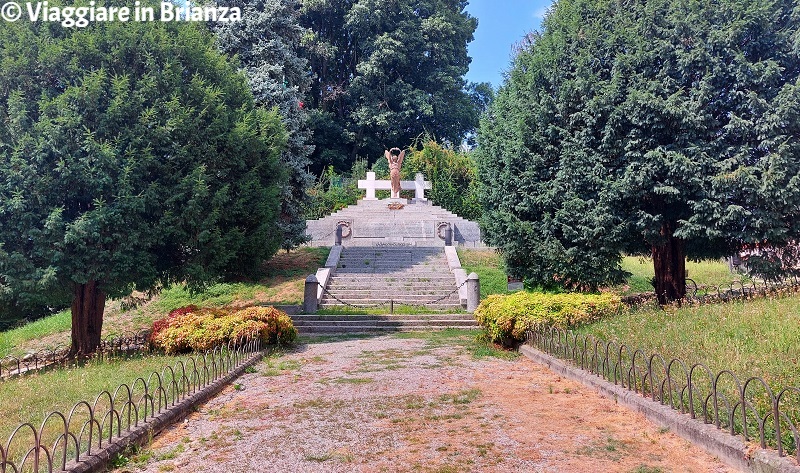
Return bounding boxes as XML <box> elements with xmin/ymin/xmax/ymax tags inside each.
<box><xmin>0</xmin><ymin>247</ymin><xmax>330</xmax><ymax>358</ymax></box>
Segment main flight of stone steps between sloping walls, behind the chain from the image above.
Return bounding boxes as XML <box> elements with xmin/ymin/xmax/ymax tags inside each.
<box><xmin>319</xmin><ymin>246</ymin><xmax>462</xmax><ymax>313</ymax></box>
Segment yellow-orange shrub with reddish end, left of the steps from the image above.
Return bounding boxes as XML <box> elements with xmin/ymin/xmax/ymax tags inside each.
<box><xmin>150</xmin><ymin>306</ymin><xmax>297</xmax><ymax>354</ymax></box>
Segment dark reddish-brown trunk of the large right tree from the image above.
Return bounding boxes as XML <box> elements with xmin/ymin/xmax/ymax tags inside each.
<box><xmin>652</xmin><ymin>223</ymin><xmax>686</xmax><ymax>304</ymax></box>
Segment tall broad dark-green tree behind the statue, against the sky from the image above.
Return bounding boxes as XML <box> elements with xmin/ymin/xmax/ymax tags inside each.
<box><xmin>301</xmin><ymin>0</ymin><xmax>479</xmax><ymax>171</ymax></box>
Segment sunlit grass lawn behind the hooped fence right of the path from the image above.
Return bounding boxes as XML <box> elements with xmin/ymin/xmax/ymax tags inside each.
<box><xmin>578</xmin><ymin>295</ymin><xmax>800</xmax><ymax>388</ymax></box>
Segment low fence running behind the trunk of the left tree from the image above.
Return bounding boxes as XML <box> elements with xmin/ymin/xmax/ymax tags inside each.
<box><xmin>0</xmin><ymin>330</ymin><xmax>150</xmax><ymax>380</ymax></box>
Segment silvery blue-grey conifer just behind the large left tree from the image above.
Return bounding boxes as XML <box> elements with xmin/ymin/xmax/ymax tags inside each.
<box><xmin>214</xmin><ymin>0</ymin><xmax>314</xmax><ymax>250</ymax></box>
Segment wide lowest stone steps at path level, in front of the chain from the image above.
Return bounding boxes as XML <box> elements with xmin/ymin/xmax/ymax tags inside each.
<box><xmin>291</xmin><ymin>314</ymin><xmax>479</xmax><ymax>335</ymax></box>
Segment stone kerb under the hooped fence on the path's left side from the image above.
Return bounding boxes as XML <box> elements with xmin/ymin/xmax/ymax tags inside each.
<box><xmin>65</xmin><ymin>350</ymin><xmax>267</xmax><ymax>473</ymax></box>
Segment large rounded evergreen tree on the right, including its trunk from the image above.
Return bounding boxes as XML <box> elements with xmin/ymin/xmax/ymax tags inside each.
<box><xmin>479</xmin><ymin>0</ymin><xmax>800</xmax><ymax>302</ymax></box>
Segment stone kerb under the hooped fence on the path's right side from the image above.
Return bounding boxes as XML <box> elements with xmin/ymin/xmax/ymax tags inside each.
<box><xmin>519</xmin><ymin>345</ymin><xmax>800</xmax><ymax>473</ymax></box>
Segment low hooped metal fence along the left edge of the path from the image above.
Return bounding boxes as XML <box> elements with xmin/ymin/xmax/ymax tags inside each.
<box><xmin>0</xmin><ymin>339</ymin><xmax>261</xmax><ymax>473</ymax></box>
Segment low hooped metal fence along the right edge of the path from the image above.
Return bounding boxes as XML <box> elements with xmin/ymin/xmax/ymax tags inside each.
<box><xmin>527</xmin><ymin>327</ymin><xmax>800</xmax><ymax>463</ymax></box>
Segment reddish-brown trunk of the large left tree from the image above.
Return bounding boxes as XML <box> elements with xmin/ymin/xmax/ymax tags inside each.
<box><xmin>70</xmin><ymin>280</ymin><xmax>106</xmax><ymax>355</ymax></box>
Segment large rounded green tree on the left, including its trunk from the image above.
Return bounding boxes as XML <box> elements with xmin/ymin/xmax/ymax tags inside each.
<box><xmin>0</xmin><ymin>12</ymin><xmax>286</xmax><ymax>353</ymax></box>
